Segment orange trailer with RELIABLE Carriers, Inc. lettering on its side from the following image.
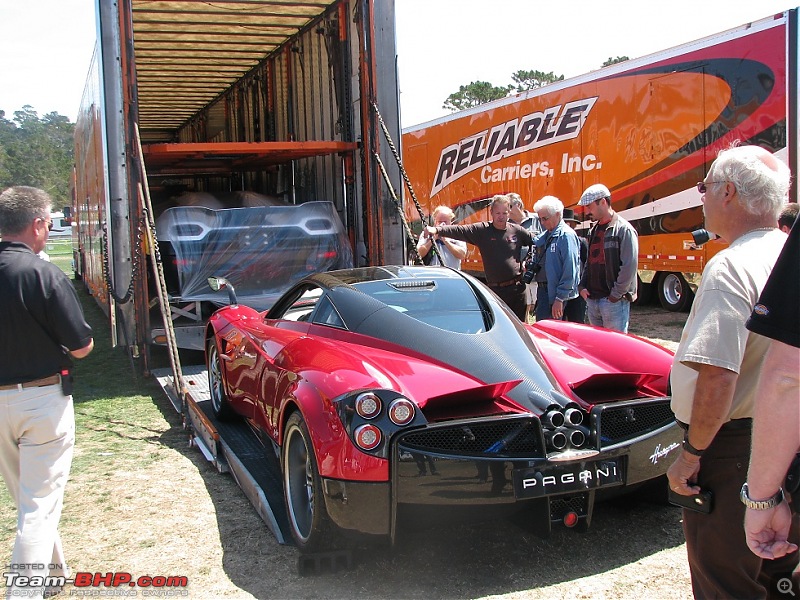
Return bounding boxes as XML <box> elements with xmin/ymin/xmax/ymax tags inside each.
<box><xmin>402</xmin><ymin>9</ymin><xmax>798</xmax><ymax>311</ymax></box>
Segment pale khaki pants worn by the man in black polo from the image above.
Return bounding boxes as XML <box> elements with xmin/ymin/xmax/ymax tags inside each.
<box><xmin>0</xmin><ymin>384</ymin><xmax>75</xmax><ymax>595</ymax></box>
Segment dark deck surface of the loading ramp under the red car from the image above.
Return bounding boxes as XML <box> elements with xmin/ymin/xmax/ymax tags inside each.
<box><xmin>153</xmin><ymin>365</ymin><xmax>292</xmax><ymax>544</ymax></box>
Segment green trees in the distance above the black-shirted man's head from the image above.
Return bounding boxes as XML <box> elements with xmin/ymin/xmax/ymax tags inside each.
<box><xmin>0</xmin><ymin>105</ymin><xmax>75</xmax><ymax>208</ymax></box>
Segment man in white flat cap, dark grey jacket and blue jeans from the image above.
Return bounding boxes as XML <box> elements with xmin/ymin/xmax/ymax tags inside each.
<box><xmin>578</xmin><ymin>183</ymin><xmax>639</xmax><ymax>333</ymax></box>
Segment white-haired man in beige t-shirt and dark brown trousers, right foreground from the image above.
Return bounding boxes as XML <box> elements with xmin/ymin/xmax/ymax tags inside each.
<box><xmin>667</xmin><ymin>146</ymin><xmax>797</xmax><ymax>598</ymax></box>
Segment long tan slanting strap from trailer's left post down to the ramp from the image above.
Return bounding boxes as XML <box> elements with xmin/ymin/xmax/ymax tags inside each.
<box><xmin>134</xmin><ymin>123</ymin><xmax>186</xmax><ymax>406</ymax></box>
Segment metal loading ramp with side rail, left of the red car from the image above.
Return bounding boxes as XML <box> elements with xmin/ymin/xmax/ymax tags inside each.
<box><xmin>153</xmin><ymin>365</ymin><xmax>292</xmax><ymax>544</ymax></box>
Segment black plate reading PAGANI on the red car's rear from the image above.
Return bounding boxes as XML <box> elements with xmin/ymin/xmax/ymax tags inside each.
<box><xmin>511</xmin><ymin>458</ymin><xmax>624</xmax><ymax>499</ymax></box>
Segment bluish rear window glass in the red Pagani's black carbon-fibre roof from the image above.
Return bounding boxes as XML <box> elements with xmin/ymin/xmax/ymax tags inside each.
<box><xmin>356</xmin><ymin>278</ymin><xmax>488</xmax><ymax>333</ymax></box>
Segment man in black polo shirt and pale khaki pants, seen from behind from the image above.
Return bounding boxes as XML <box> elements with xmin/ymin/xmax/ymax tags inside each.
<box><xmin>0</xmin><ymin>186</ymin><xmax>94</xmax><ymax>595</ymax></box>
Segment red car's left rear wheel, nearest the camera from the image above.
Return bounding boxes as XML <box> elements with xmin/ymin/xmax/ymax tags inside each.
<box><xmin>281</xmin><ymin>412</ymin><xmax>337</xmax><ymax>552</ymax></box>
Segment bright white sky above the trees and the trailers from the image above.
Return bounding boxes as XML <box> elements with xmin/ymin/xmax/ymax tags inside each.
<box><xmin>0</xmin><ymin>0</ymin><xmax>800</xmax><ymax>127</ymax></box>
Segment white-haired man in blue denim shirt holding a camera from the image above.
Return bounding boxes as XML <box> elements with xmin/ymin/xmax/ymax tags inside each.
<box><xmin>523</xmin><ymin>196</ymin><xmax>580</xmax><ymax>321</ymax></box>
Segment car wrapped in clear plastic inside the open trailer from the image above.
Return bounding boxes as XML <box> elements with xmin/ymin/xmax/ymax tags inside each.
<box><xmin>156</xmin><ymin>202</ymin><xmax>353</xmax><ymax>310</ymax></box>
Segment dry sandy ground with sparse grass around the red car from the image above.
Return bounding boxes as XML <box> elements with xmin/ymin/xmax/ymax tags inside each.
<box><xmin>0</xmin><ymin>307</ymin><xmax>691</xmax><ymax>600</ymax></box>
